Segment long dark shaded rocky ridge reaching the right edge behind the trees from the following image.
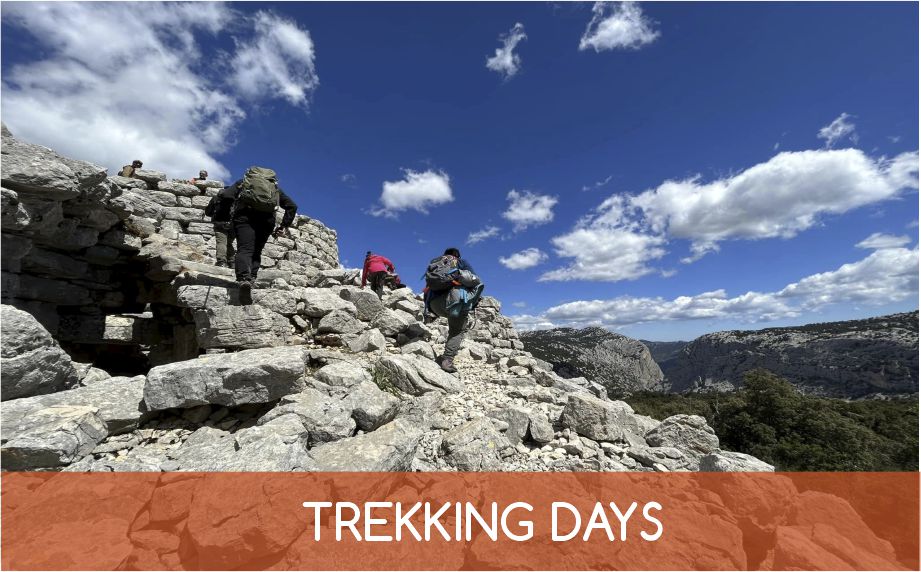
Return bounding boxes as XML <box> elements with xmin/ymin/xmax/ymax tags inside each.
<box><xmin>661</xmin><ymin>311</ymin><xmax>918</xmax><ymax>398</ymax></box>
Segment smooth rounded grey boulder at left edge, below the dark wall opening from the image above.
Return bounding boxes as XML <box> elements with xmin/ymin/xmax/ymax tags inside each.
<box><xmin>0</xmin><ymin>304</ymin><xmax>80</xmax><ymax>401</ymax></box>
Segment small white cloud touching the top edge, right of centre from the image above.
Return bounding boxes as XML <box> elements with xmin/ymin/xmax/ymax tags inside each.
<box><xmin>579</xmin><ymin>2</ymin><xmax>659</xmax><ymax>52</ymax></box>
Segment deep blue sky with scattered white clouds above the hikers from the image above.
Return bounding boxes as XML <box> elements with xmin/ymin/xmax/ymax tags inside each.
<box><xmin>2</xmin><ymin>2</ymin><xmax>918</xmax><ymax>340</ymax></box>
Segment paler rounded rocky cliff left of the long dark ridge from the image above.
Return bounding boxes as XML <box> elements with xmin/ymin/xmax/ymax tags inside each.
<box><xmin>522</xmin><ymin>328</ymin><xmax>663</xmax><ymax>394</ymax></box>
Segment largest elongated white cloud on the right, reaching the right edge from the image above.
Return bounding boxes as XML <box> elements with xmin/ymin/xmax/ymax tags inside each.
<box><xmin>547</xmin><ymin>149</ymin><xmax>918</xmax><ymax>280</ymax></box>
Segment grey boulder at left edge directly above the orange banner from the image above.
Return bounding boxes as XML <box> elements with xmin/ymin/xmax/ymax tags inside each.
<box><xmin>0</xmin><ymin>406</ymin><xmax>106</xmax><ymax>471</ymax></box>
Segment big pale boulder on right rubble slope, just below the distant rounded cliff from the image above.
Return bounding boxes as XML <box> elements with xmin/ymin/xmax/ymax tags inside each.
<box><xmin>560</xmin><ymin>393</ymin><xmax>646</xmax><ymax>445</ymax></box>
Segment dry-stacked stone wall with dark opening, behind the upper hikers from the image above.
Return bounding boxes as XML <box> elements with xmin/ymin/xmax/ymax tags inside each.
<box><xmin>0</xmin><ymin>126</ymin><xmax>343</xmax><ymax>374</ymax></box>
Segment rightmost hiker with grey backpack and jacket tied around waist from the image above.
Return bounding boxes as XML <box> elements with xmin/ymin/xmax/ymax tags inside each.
<box><xmin>425</xmin><ymin>248</ymin><xmax>483</xmax><ymax>373</ymax></box>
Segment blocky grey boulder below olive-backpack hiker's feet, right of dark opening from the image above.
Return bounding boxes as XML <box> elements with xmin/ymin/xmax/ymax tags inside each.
<box><xmin>194</xmin><ymin>306</ymin><xmax>291</xmax><ymax>349</ymax></box>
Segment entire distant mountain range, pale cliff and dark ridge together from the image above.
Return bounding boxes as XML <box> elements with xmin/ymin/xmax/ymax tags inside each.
<box><xmin>521</xmin><ymin>311</ymin><xmax>918</xmax><ymax>399</ymax></box>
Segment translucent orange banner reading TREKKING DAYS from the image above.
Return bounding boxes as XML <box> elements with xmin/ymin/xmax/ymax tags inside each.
<box><xmin>2</xmin><ymin>473</ymin><xmax>919</xmax><ymax>570</ymax></box>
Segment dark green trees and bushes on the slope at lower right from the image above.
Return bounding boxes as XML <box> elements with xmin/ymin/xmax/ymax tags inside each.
<box><xmin>625</xmin><ymin>370</ymin><xmax>918</xmax><ymax>471</ymax></box>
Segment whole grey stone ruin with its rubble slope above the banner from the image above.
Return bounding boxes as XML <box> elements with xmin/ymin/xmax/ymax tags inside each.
<box><xmin>0</xmin><ymin>128</ymin><xmax>772</xmax><ymax>471</ymax></box>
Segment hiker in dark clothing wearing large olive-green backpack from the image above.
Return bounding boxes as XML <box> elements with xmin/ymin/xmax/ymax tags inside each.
<box><xmin>230</xmin><ymin>167</ymin><xmax>297</xmax><ymax>304</ymax></box>
